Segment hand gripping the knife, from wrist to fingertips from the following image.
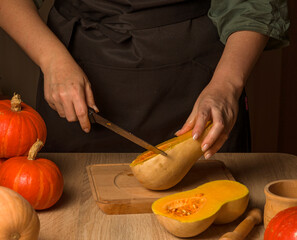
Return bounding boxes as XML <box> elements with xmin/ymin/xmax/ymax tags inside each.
<box><xmin>42</xmin><ymin>54</ymin><xmax>99</xmax><ymax>132</ymax></box>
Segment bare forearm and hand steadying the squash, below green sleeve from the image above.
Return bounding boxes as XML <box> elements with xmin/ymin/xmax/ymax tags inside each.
<box><xmin>176</xmin><ymin>31</ymin><xmax>269</xmax><ymax>159</ymax></box>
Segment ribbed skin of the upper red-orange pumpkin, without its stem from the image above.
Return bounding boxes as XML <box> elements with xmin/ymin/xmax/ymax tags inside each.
<box><xmin>0</xmin><ymin>100</ymin><xmax>47</xmax><ymax>158</ymax></box>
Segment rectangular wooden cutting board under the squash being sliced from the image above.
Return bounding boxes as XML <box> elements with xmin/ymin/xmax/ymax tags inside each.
<box><xmin>87</xmin><ymin>160</ymin><xmax>234</xmax><ymax>214</ymax></box>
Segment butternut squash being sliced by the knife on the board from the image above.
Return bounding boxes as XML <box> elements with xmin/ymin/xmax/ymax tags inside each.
<box><xmin>130</xmin><ymin>122</ymin><xmax>212</xmax><ymax>190</ymax></box>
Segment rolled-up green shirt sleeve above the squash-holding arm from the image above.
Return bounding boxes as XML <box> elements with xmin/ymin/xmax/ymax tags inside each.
<box><xmin>208</xmin><ymin>0</ymin><xmax>290</xmax><ymax>49</ymax></box>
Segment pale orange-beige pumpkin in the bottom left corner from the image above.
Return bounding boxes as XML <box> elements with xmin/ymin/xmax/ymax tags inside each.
<box><xmin>0</xmin><ymin>186</ymin><xmax>40</xmax><ymax>240</ymax></box>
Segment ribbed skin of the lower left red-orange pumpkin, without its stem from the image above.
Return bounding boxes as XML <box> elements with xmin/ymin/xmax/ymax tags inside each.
<box><xmin>0</xmin><ymin>157</ymin><xmax>64</xmax><ymax>210</ymax></box>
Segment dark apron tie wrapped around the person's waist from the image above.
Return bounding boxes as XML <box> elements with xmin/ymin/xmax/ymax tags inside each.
<box><xmin>56</xmin><ymin>0</ymin><xmax>210</xmax><ymax>43</ymax></box>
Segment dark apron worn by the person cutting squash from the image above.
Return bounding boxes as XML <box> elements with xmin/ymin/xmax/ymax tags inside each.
<box><xmin>37</xmin><ymin>0</ymin><xmax>250</xmax><ymax>152</ymax></box>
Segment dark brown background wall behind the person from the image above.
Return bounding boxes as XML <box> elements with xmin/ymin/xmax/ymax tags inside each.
<box><xmin>0</xmin><ymin>0</ymin><xmax>297</xmax><ymax>155</ymax></box>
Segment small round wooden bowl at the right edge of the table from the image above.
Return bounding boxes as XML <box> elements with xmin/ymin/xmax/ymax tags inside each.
<box><xmin>264</xmin><ymin>179</ymin><xmax>297</xmax><ymax>228</ymax></box>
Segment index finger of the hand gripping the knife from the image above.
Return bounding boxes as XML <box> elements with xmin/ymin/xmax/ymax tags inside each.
<box><xmin>73</xmin><ymin>88</ymin><xmax>91</xmax><ymax>133</ymax></box>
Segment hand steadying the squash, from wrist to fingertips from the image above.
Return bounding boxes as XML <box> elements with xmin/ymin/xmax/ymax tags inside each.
<box><xmin>176</xmin><ymin>81</ymin><xmax>238</xmax><ymax>159</ymax></box>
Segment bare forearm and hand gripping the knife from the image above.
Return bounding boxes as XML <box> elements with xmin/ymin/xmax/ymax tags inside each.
<box><xmin>0</xmin><ymin>0</ymin><xmax>98</xmax><ymax>132</ymax></box>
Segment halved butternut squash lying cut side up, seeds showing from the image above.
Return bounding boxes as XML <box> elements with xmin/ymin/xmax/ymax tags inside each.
<box><xmin>152</xmin><ymin>180</ymin><xmax>249</xmax><ymax>237</ymax></box>
